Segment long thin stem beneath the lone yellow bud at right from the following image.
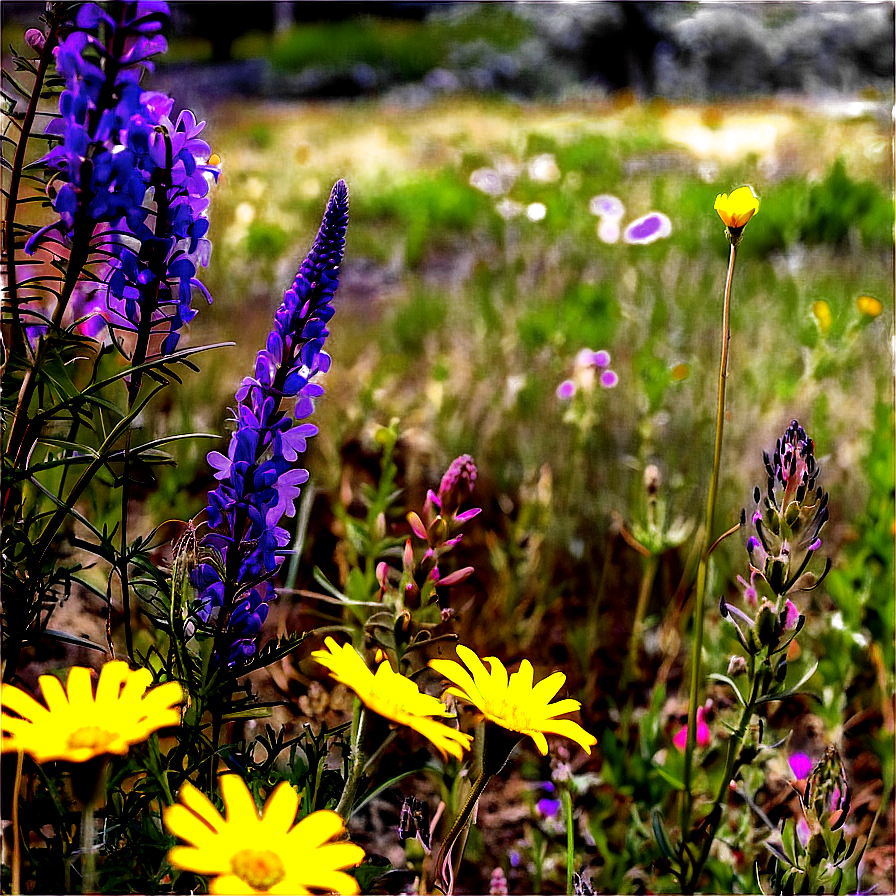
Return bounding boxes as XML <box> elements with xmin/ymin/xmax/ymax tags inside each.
<box><xmin>679</xmin><ymin>241</ymin><xmax>737</xmax><ymax>860</ymax></box>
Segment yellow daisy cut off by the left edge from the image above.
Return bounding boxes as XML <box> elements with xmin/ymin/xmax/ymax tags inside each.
<box><xmin>0</xmin><ymin>660</ymin><xmax>183</xmax><ymax>762</ymax></box>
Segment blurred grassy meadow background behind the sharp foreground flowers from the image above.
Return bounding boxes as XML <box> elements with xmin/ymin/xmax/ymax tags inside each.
<box><xmin>4</xmin><ymin>3</ymin><xmax>894</xmax><ymax>892</ymax></box>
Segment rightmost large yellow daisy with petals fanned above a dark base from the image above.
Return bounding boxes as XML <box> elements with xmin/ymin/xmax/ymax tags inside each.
<box><xmin>429</xmin><ymin>644</ymin><xmax>597</xmax><ymax>756</ymax></box>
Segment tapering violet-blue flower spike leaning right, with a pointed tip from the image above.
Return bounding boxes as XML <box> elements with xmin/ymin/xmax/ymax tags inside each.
<box><xmin>187</xmin><ymin>180</ymin><xmax>348</xmax><ymax>666</ymax></box>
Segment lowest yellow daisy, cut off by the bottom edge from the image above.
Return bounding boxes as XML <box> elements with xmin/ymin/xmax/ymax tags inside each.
<box><xmin>162</xmin><ymin>775</ymin><xmax>364</xmax><ymax>896</ymax></box>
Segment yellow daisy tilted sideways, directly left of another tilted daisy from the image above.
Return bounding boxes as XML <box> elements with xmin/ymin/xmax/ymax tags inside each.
<box><xmin>311</xmin><ymin>638</ymin><xmax>473</xmax><ymax>759</ymax></box>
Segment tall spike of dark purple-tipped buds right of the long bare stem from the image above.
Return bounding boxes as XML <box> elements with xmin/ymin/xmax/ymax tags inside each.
<box><xmin>720</xmin><ymin>420</ymin><xmax>828</xmax><ymax>654</ymax></box>
